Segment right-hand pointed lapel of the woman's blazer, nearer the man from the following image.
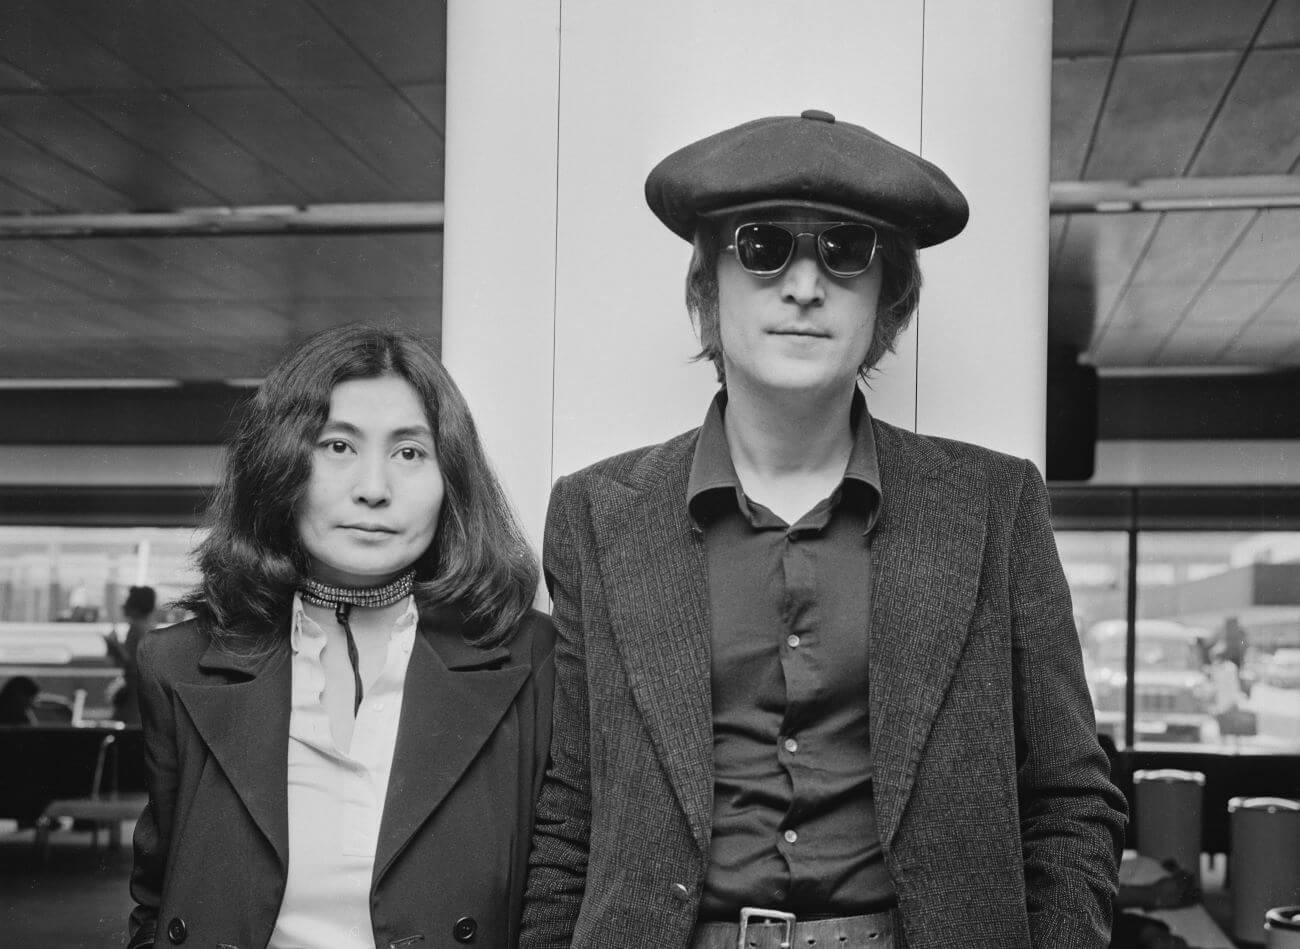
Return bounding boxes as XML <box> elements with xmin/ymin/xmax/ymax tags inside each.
<box><xmin>373</xmin><ymin>608</ymin><xmax>530</xmax><ymax>883</ymax></box>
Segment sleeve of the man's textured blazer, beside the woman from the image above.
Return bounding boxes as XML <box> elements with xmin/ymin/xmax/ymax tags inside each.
<box><xmin>519</xmin><ymin>478</ymin><xmax>592</xmax><ymax>949</ymax></box>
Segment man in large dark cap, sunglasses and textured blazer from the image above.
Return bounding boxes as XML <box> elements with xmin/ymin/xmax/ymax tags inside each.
<box><xmin>521</xmin><ymin>111</ymin><xmax>1125</xmax><ymax>949</ymax></box>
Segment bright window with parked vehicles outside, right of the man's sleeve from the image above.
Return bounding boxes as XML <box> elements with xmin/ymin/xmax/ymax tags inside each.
<box><xmin>1057</xmin><ymin>520</ymin><xmax>1300</xmax><ymax>753</ymax></box>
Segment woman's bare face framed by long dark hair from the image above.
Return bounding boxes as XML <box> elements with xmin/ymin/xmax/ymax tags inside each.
<box><xmin>298</xmin><ymin>376</ymin><xmax>443</xmax><ymax>586</ymax></box>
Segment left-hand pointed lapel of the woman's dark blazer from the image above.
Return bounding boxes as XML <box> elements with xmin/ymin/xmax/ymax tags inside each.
<box><xmin>176</xmin><ymin>645</ymin><xmax>291</xmax><ymax>868</ymax></box>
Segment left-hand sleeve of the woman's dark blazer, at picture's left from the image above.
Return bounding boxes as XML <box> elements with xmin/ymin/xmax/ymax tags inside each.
<box><xmin>127</xmin><ymin>636</ymin><xmax>177</xmax><ymax>949</ymax></box>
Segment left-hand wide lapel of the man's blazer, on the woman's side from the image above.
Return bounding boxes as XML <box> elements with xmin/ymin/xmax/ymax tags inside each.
<box><xmin>592</xmin><ymin>437</ymin><xmax>714</xmax><ymax>853</ymax></box>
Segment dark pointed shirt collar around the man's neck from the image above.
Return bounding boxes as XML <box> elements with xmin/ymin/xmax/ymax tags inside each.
<box><xmin>686</xmin><ymin>386</ymin><xmax>884</xmax><ymax>532</ymax></box>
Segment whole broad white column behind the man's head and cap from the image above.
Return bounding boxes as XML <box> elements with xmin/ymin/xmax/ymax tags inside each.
<box><xmin>443</xmin><ymin>0</ymin><xmax>1050</xmax><ymax>540</ymax></box>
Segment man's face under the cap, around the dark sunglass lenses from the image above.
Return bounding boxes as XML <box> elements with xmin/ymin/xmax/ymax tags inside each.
<box><xmin>718</xmin><ymin>211</ymin><xmax>880</xmax><ymax>395</ymax></box>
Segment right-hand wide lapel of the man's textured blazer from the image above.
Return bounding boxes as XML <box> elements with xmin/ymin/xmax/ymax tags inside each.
<box><xmin>868</xmin><ymin>423</ymin><xmax>988</xmax><ymax>845</ymax></box>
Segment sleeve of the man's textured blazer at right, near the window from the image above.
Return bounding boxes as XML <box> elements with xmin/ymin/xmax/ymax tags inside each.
<box><xmin>1010</xmin><ymin>462</ymin><xmax>1127</xmax><ymax>949</ymax></box>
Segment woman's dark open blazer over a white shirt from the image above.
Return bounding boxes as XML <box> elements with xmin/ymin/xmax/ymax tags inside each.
<box><xmin>130</xmin><ymin>608</ymin><xmax>555</xmax><ymax>949</ymax></box>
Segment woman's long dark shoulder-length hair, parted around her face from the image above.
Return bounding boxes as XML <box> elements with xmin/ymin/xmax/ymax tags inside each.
<box><xmin>179</xmin><ymin>324</ymin><xmax>538</xmax><ymax>651</ymax></box>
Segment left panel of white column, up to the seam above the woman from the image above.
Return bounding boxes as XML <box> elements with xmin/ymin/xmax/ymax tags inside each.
<box><xmin>442</xmin><ymin>0</ymin><xmax>560</xmax><ymax>546</ymax></box>
